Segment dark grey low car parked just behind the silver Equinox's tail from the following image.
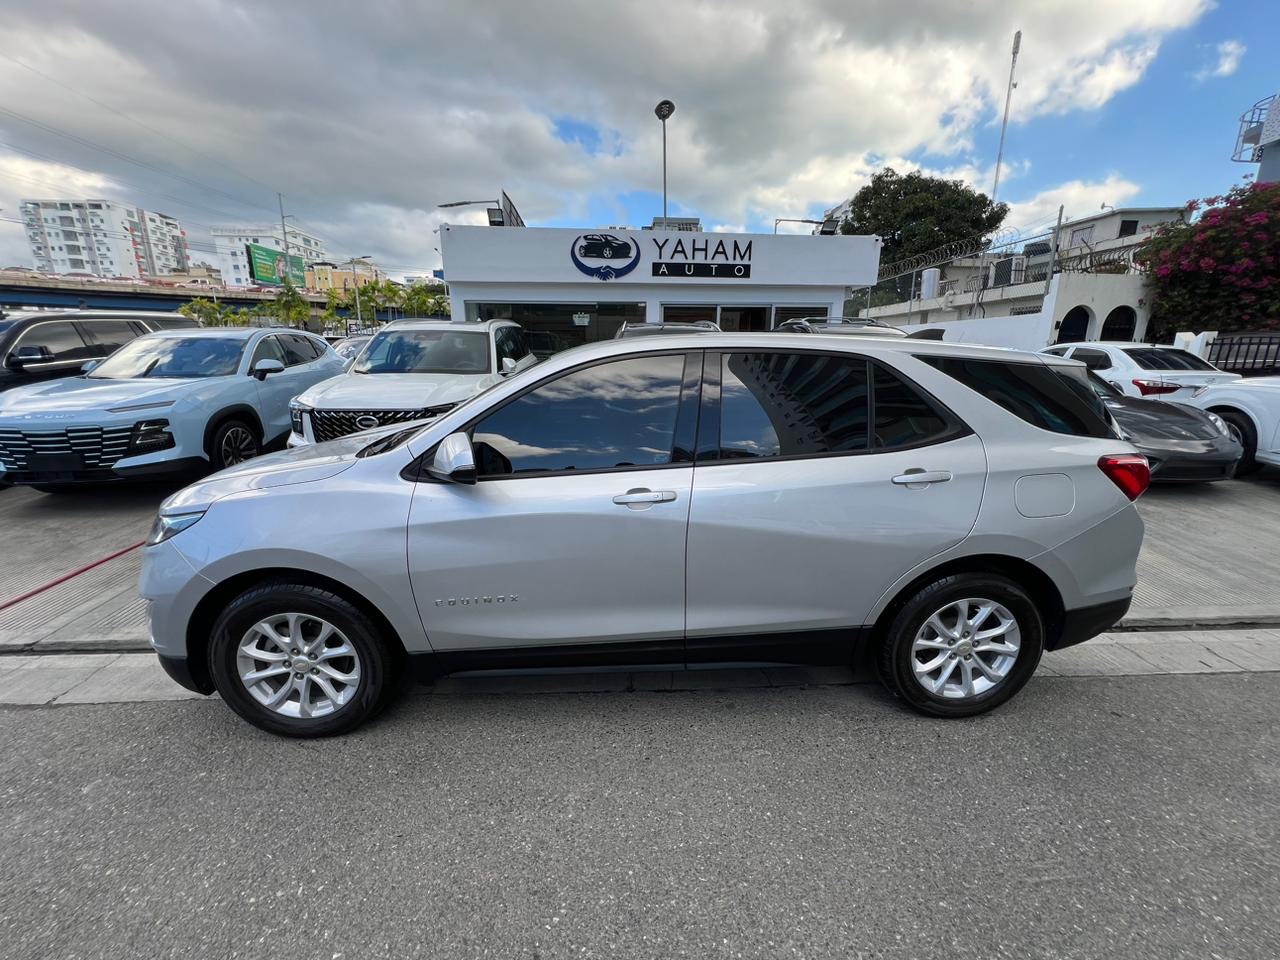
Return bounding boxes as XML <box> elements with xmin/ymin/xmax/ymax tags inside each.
<box><xmin>1089</xmin><ymin>370</ymin><xmax>1244</xmax><ymax>483</ymax></box>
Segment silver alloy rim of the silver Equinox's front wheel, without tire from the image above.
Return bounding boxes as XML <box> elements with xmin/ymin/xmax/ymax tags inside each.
<box><xmin>236</xmin><ymin>613</ymin><xmax>361</xmax><ymax>719</ymax></box>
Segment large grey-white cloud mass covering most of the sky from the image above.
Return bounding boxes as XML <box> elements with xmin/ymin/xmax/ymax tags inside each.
<box><xmin>0</xmin><ymin>0</ymin><xmax>1211</xmax><ymax>269</ymax></box>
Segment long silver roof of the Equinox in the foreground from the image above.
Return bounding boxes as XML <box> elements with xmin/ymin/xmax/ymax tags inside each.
<box><xmin>539</xmin><ymin>330</ymin><xmax>1064</xmax><ymax>367</ymax></box>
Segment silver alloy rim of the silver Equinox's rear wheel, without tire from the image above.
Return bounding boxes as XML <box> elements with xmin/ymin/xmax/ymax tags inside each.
<box><xmin>911</xmin><ymin>596</ymin><xmax>1021</xmax><ymax>700</ymax></box>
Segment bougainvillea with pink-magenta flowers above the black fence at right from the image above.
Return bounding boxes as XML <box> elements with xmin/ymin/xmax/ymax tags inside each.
<box><xmin>1134</xmin><ymin>183</ymin><xmax>1280</xmax><ymax>338</ymax></box>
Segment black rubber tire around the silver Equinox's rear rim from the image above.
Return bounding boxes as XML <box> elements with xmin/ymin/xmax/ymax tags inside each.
<box><xmin>877</xmin><ymin>573</ymin><xmax>1044</xmax><ymax>717</ymax></box>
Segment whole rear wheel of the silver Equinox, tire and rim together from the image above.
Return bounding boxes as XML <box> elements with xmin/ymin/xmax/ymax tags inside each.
<box><xmin>878</xmin><ymin>573</ymin><xmax>1044</xmax><ymax>717</ymax></box>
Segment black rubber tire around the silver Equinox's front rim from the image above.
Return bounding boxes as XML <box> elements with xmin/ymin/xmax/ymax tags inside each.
<box><xmin>209</xmin><ymin>581</ymin><xmax>399</xmax><ymax>737</ymax></box>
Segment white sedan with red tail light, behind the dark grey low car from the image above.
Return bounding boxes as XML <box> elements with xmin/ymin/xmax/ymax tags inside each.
<box><xmin>1041</xmin><ymin>342</ymin><xmax>1240</xmax><ymax>402</ymax></box>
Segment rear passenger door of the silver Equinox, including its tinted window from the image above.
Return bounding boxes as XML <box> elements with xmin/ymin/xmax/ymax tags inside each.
<box><xmin>687</xmin><ymin>349</ymin><xmax>987</xmax><ymax>650</ymax></box>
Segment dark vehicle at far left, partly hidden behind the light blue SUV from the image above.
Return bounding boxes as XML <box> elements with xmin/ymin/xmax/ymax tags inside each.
<box><xmin>0</xmin><ymin>310</ymin><xmax>200</xmax><ymax>390</ymax></box>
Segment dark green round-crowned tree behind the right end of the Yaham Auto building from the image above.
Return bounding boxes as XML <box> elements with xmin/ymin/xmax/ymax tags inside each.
<box><xmin>840</xmin><ymin>166</ymin><xmax>1009</xmax><ymax>276</ymax></box>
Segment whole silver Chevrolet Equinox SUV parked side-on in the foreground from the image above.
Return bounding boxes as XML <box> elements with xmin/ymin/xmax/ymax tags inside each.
<box><xmin>141</xmin><ymin>333</ymin><xmax>1148</xmax><ymax>736</ymax></box>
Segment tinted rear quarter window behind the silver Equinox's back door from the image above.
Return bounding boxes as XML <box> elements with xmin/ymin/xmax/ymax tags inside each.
<box><xmin>918</xmin><ymin>357</ymin><xmax>1115</xmax><ymax>438</ymax></box>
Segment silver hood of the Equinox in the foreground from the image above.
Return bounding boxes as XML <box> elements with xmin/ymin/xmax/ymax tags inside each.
<box><xmin>160</xmin><ymin>424</ymin><xmax>389</xmax><ymax>515</ymax></box>
